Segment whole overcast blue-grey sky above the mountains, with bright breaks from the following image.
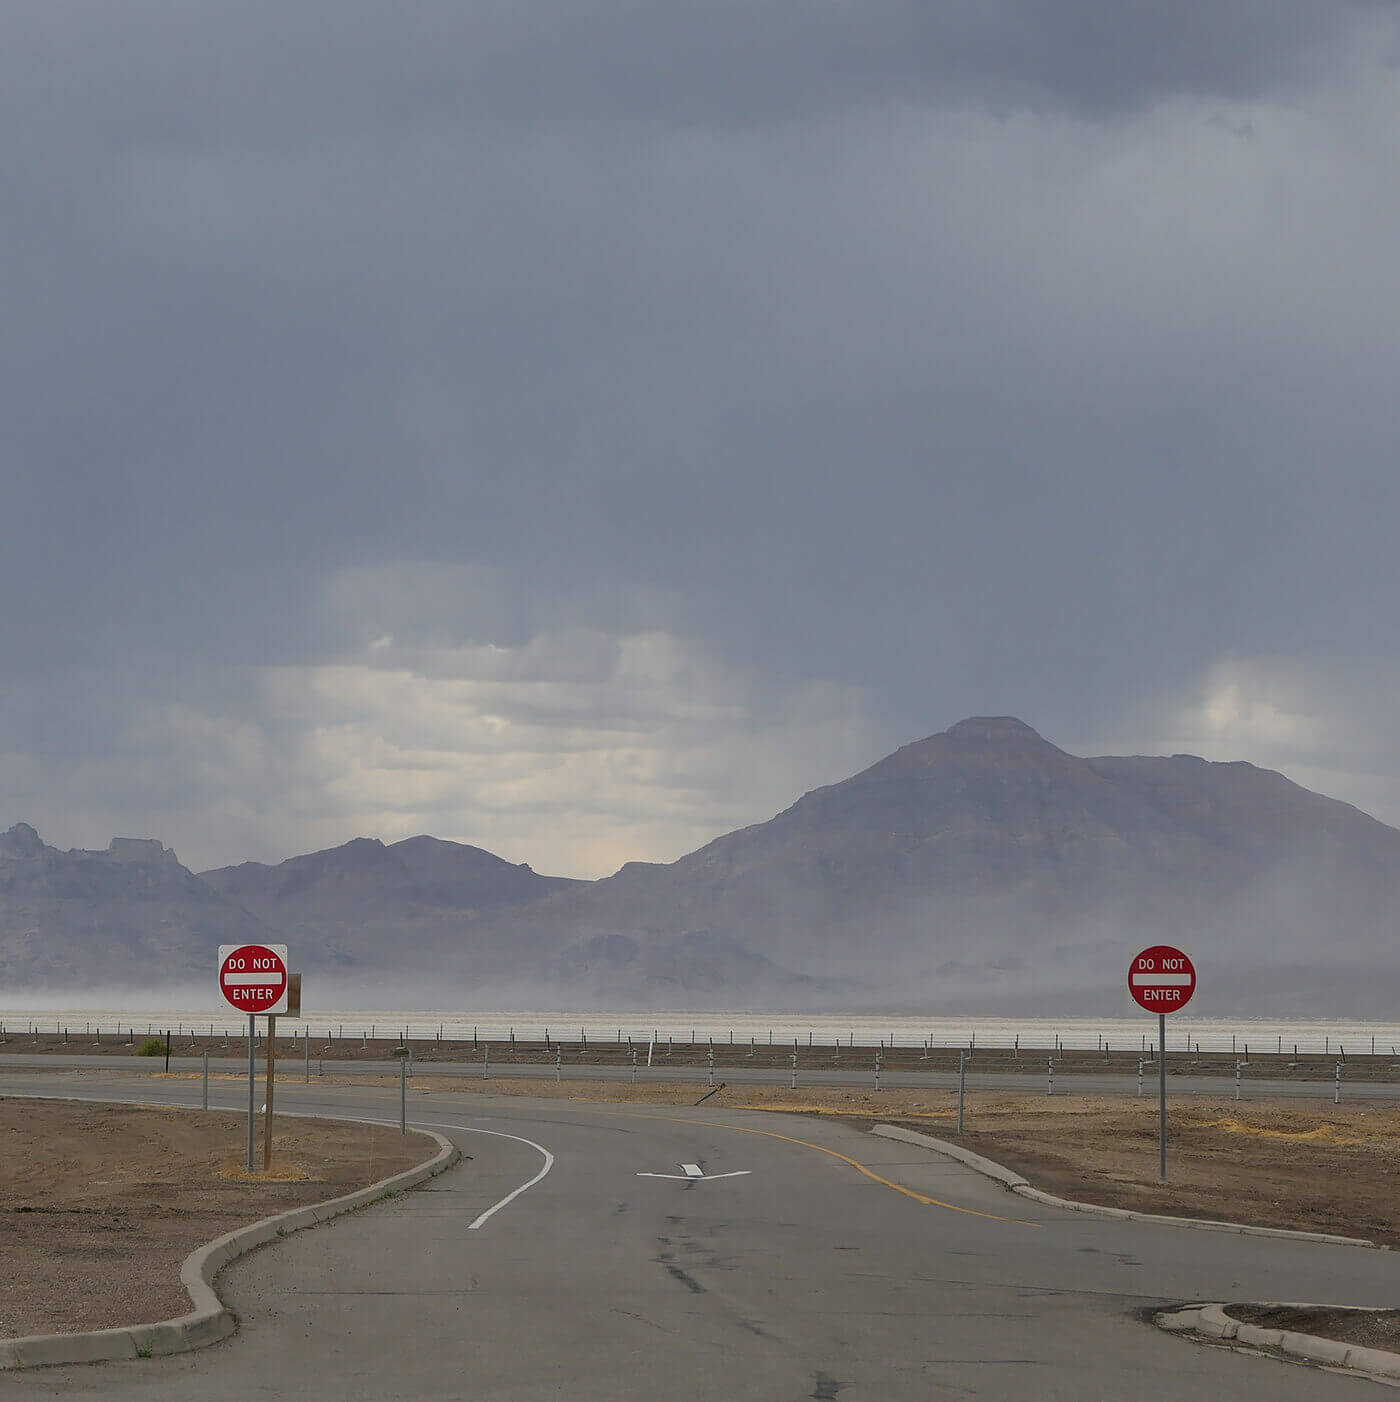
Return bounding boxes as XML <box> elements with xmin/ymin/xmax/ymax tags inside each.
<box><xmin>0</xmin><ymin>0</ymin><xmax>1400</xmax><ymax>876</ymax></box>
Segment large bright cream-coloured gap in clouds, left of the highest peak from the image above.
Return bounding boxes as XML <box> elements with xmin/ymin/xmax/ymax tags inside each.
<box><xmin>261</xmin><ymin>631</ymin><xmax>869</xmax><ymax>878</ymax></box>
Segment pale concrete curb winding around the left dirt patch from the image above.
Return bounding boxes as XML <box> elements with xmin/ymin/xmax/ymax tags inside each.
<box><xmin>0</xmin><ymin>1105</ymin><xmax>461</xmax><ymax>1370</ymax></box>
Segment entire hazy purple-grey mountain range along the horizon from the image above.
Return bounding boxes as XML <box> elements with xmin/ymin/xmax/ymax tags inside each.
<box><xmin>0</xmin><ymin>716</ymin><xmax>1400</xmax><ymax>1016</ymax></box>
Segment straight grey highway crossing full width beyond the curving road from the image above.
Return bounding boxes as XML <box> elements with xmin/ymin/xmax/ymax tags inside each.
<box><xmin>0</xmin><ymin>1053</ymin><xmax>1400</xmax><ymax>1105</ymax></box>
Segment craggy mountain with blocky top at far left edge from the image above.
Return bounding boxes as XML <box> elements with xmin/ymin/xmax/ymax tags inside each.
<box><xmin>0</xmin><ymin>823</ymin><xmax>273</xmax><ymax>988</ymax></box>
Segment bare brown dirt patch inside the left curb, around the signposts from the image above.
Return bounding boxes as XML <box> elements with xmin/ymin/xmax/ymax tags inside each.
<box><xmin>0</xmin><ymin>1098</ymin><xmax>437</xmax><ymax>1338</ymax></box>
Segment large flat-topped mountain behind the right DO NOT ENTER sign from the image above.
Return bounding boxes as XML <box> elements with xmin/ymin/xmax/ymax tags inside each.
<box><xmin>448</xmin><ymin>716</ymin><xmax>1400</xmax><ymax>1015</ymax></box>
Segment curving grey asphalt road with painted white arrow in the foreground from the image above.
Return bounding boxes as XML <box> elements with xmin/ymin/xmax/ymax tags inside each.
<box><xmin>0</xmin><ymin>1071</ymin><xmax>1400</xmax><ymax>1402</ymax></box>
